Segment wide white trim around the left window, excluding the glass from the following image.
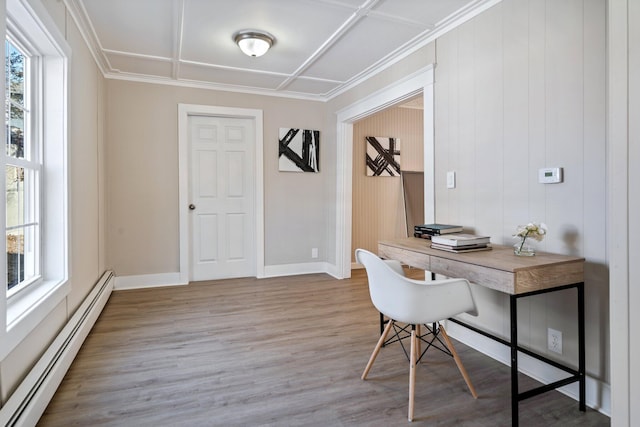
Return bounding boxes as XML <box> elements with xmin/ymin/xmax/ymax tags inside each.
<box><xmin>0</xmin><ymin>0</ymin><xmax>71</xmax><ymax>360</ymax></box>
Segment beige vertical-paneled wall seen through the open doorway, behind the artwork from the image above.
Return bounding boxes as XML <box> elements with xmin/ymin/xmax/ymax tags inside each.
<box><xmin>351</xmin><ymin>107</ymin><xmax>424</xmax><ymax>262</ymax></box>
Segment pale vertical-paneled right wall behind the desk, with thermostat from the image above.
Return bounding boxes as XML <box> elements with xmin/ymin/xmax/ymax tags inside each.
<box><xmin>435</xmin><ymin>0</ymin><xmax>609</xmax><ymax>383</ymax></box>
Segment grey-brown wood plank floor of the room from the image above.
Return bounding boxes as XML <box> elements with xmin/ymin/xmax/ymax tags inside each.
<box><xmin>38</xmin><ymin>270</ymin><xmax>610</xmax><ymax>427</ymax></box>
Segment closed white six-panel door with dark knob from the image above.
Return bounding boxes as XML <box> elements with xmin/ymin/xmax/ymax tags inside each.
<box><xmin>188</xmin><ymin>116</ymin><xmax>256</xmax><ymax>281</ymax></box>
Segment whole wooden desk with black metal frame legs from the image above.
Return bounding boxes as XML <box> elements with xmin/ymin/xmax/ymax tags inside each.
<box><xmin>378</xmin><ymin>237</ymin><xmax>586</xmax><ymax>426</ymax></box>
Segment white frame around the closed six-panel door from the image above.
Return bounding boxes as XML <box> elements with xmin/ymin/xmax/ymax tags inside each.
<box><xmin>178</xmin><ymin>104</ymin><xmax>264</xmax><ymax>284</ymax></box>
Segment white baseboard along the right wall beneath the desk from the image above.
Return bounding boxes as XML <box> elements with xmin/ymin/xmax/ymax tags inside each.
<box><xmin>446</xmin><ymin>322</ymin><xmax>611</xmax><ymax>417</ymax></box>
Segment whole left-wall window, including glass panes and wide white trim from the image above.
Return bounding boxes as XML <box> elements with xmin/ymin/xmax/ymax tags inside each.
<box><xmin>0</xmin><ymin>0</ymin><xmax>71</xmax><ymax>360</ymax></box>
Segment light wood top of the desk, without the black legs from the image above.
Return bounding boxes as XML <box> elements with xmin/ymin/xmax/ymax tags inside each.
<box><xmin>378</xmin><ymin>237</ymin><xmax>584</xmax><ymax>294</ymax></box>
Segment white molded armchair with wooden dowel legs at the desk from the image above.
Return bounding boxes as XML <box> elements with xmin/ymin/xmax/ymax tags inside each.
<box><xmin>356</xmin><ymin>249</ymin><xmax>478</xmax><ymax>421</ymax></box>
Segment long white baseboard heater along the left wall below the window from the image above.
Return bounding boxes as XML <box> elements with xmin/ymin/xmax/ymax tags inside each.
<box><xmin>0</xmin><ymin>271</ymin><xmax>115</xmax><ymax>427</ymax></box>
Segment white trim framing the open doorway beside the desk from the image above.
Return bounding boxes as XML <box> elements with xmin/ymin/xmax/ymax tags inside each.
<box><xmin>333</xmin><ymin>65</ymin><xmax>435</xmax><ymax>279</ymax></box>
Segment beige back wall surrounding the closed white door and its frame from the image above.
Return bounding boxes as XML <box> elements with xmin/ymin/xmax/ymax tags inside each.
<box><xmin>106</xmin><ymin>80</ymin><xmax>332</xmax><ymax>276</ymax></box>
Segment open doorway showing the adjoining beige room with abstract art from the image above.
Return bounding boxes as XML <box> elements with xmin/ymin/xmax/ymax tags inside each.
<box><xmin>351</xmin><ymin>93</ymin><xmax>424</xmax><ymax>269</ymax></box>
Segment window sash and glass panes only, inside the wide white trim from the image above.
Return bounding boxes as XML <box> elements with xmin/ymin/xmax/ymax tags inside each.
<box><xmin>4</xmin><ymin>37</ymin><xmax>40</xmax><ymax>296</ymax></box>
